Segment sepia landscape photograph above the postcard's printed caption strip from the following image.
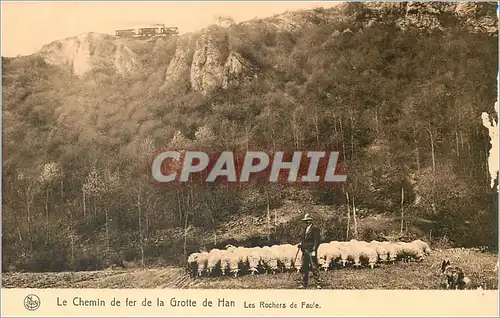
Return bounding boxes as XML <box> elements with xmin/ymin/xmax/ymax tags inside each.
<box><xmin>1</xmin><ymin>1</ymin><xmax>499</xmax><ymax>296</ymax></box>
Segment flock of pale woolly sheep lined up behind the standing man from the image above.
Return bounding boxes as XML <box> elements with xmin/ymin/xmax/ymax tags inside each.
<box><xmin>187</xmin><ymin>240</ymin><xmax>431</xmax><ymax>277</ymax></box>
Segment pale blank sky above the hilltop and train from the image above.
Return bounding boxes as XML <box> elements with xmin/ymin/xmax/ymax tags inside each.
<box><xmin>1</xmin><ymin>1</ymin><xmax>339</xmax><ymax>57</ymax></box>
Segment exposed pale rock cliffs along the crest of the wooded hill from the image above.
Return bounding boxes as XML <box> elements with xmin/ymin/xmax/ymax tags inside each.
<box><xmin>34</xmin><ymin>2</ymin><xmax>497</xmax><ymax>93</ymax></box>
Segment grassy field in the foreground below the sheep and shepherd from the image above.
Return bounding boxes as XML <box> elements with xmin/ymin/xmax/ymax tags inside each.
<box><xmin>2</xmin><ymin>249</ymin><xmax>498</xmax><ymax>289</ymax></box>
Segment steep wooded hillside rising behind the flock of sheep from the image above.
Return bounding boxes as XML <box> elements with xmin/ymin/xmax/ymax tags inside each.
<box><xmin>2</xmin><ymin>3</ymin><xmax>498</xmax><ymax>271</ymax></box>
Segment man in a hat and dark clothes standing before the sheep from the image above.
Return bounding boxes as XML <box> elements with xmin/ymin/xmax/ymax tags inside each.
<box><xmin>298</xmin><ymin>214</ymin><xmax>321</xmax><ymax>288</ymax></box>
